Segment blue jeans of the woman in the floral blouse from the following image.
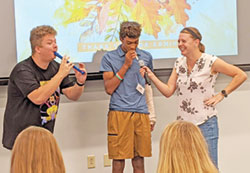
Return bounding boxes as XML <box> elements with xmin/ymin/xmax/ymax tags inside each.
<box><xmin>198</xmin><ymin>116</ymin><xmax>219</xmax><ymax>168</ymax></box>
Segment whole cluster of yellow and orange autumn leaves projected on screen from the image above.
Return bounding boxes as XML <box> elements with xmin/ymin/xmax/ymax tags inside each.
<box><xmin>55</xmin><ymin>0</ymin><xmax>191</xmax><ymax>42</ymax></box>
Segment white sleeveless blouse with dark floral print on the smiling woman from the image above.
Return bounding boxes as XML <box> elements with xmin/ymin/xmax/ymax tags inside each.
<box><xmin>175</xmin><ymin>53</ymin><xmax>218</xmax><ymax>125</ymax></box>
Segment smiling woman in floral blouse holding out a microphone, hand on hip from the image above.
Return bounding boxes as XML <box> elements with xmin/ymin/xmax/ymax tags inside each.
<box><xmin>141</xmin><ymin>27</ymin><xmax>247</xmax><ymax>167</ymax></box>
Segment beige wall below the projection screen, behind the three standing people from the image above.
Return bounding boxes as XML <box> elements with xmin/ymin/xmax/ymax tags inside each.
<box><xmin>0</xmin><ymin>72</ymin><xmax>250</xmax><ymax>173</ymax></box>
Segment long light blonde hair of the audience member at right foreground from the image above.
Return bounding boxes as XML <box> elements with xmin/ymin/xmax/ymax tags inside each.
<box><xmin>157</xmin><ymin>120</ymin><xmax>218</xmax><ymax>173</ymax></box>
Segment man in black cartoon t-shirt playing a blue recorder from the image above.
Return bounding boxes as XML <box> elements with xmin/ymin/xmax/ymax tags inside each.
<box><xmin>2</xmin><ymin>25</ymin><xmax>87</xmax><ymax>149</ymax></box>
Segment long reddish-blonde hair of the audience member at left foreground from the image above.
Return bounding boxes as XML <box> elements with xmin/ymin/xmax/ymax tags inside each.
<box><xmin>10</xmin><ymin>126</ymin><xmax>65</xmax><ymax>173</ymax></box>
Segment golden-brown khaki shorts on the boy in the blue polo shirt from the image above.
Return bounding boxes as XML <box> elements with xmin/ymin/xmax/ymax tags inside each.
<box><xmin>108</xmin><ymin>111</ymin><xmax>152</xmax><ymax>160</ymax></box>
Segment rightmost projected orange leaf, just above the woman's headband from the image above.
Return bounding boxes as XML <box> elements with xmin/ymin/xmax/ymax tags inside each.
<box><xmin>168</xmin><ymin>0</ymin><xmax>191</xmax><ymax>26</ymax></box>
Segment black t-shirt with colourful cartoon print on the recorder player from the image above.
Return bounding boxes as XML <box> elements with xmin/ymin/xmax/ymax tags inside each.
<box><xmin>2</xmin><ymin>57</ymin><xmax>74</xmax><ymax>149</ymax></box>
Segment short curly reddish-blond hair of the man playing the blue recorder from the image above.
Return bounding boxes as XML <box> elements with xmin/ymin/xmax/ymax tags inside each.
<box><xmin>30</xmin><ymin>25</ymin><xmax>57</xmax><ymax>55</ymax></box>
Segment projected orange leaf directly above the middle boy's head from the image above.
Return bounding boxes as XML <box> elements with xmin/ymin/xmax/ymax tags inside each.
<box><xmin>131</xmin><ymin>0</ymin><xmax>161</xmax><ymax>38</ymax></box>
